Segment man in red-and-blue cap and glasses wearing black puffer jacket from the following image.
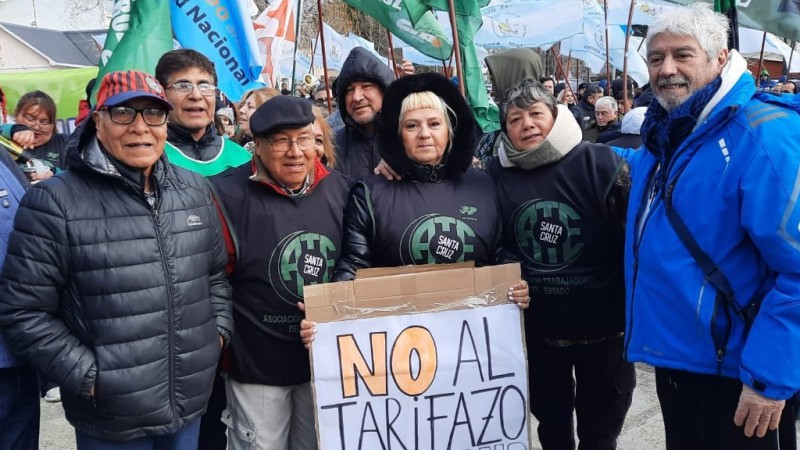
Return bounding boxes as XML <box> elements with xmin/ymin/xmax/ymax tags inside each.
<box><xmin>0</xmin><ymin>70</ymin><xmax>233</xmax><ymax>449</ymax></box>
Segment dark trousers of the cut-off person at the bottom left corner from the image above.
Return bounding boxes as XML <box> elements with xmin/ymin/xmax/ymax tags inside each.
<box><xmin>0</xmin><ymin>364</ymin><xmax>39</xmax><ymax>450</ymax></box>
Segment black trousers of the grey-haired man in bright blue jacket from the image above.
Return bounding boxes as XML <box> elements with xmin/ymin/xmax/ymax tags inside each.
<box><xmin>656</xmin><ymin>368</ymin><xmax>778</xmax><ymax>450</ymax></box>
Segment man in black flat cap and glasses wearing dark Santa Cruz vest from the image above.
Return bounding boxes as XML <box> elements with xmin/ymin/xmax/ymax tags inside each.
<box><xmin>212</xmin><ymin>96</ymin><xmax>349</xmax><ymax>450</ymax></box>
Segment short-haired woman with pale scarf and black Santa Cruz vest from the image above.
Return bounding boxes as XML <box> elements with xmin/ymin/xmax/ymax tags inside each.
<box><xmin>487</xmin><ymin>80</ymin><xmax>636</xmax><ymax>450</ymax></box>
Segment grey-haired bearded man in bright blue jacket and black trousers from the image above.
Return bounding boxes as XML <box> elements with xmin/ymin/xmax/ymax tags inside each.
<box><xmin>626</xmin><ymin>5</ymin><xmax>800</xmax><ymax>449</ymax></box>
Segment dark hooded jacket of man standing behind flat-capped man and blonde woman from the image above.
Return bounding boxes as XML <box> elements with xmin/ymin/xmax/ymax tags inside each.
<box><xmin>335</xmin><ymin>47</ymin><xmax>394</xmax><ymax>180</ymax></box>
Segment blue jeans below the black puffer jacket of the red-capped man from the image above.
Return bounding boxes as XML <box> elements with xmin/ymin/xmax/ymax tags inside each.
<box><xmin>75</xmin><ymin>419</ymin><xmax>200</xmax><ymax>450</ymax></box>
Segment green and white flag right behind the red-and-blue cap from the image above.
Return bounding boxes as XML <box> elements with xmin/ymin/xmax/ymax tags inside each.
<box><xmin>92</xmin><ymin>0</ymin><xmax>173</xmax><ymax>105</ymax></box>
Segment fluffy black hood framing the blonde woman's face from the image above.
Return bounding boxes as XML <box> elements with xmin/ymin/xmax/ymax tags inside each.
<box><xmin>377</xmin><ymin>73</ymin><xmax>480</xmax><ymax>181</ymax></box>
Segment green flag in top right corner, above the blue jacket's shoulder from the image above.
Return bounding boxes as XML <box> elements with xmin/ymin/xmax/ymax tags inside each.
<box><xmin>667</xmin><ymin>0</ymin><xmax>800</xmax><ymax>41</ymax></box>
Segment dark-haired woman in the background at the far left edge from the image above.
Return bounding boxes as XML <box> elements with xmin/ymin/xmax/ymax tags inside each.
<box><xmin>1</xmin><ymin>91</ymin><xmax>67</xmax><ymax>181</ymax></box>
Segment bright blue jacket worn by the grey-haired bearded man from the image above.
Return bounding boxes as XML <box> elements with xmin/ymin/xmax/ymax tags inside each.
<box><xmin>625</xmin><ymin>52</ymin><xmax>800</xmax><ymax>399</ymax></box>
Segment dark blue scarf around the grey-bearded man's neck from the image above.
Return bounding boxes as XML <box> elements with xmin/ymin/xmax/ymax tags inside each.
<box><xmin>642</xmin><ymin>77</ymin><xmax>722</xmax><ymax>167</ymax></box>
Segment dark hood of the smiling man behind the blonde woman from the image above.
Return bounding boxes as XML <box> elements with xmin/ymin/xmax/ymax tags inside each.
<box><xmin>336</xmin><ymin>47</ymin><xmax>395</xmax><ymax>125</ymax></box>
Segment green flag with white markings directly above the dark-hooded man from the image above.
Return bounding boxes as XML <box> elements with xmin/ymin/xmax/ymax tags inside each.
<box><xmin>344</xmin><ymin>0</ymin><xmax>453</xmax><ymax>61</ymax></box>
